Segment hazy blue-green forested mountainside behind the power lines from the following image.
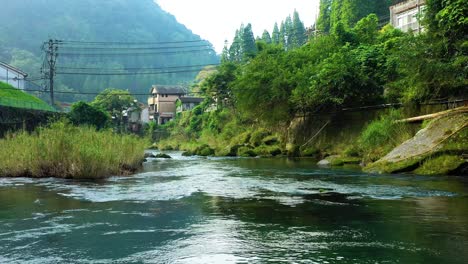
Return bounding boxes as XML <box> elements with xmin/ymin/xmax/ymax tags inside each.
<box><xmin>0</xmin><ymin>0</ymin><xmax>218</xmax><ymax>101</ymax></box>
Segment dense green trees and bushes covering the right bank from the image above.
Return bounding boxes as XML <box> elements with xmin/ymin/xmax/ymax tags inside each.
<box><xmin>159</xmin><ymin>0</ymin><xmax>468</xmax><ymax>166</ymax></box>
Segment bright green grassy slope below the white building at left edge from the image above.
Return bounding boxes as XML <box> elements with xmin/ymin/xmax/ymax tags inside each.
<box><xmin>0</xmin><ymin>82</ymin><xmax>55</xmax><ymax>112</ymax></box>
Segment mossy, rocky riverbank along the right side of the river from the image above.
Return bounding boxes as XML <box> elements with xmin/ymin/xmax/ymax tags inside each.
<box><xmin>154</xmin><ymin>110</ymin><xmax>468</xmax><ymax>174</ymax></box>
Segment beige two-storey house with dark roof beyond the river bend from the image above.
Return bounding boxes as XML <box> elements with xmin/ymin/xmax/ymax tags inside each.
<box><xmin>148</xmin><ymin>85</ymin><xmax>187</xmax><ymax>125</ymax></box>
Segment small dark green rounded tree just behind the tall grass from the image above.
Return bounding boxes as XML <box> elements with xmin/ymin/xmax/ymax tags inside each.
<box><xmin>68</xmin><ymin>101</ymin><xmax>110</xmax><ymax>130</ymax></box>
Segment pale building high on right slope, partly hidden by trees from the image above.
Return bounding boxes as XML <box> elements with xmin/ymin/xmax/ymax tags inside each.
<box><xmin>390</xmin><ymin>0</ymin><xmax>426</xmax><ymax>33</ymax></box>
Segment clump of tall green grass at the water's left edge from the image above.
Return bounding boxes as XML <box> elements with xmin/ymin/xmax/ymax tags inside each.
<box><xmin>0</xmin><ymin>121</ymin><xmax>147</xmax><ymax>179</ymax></box>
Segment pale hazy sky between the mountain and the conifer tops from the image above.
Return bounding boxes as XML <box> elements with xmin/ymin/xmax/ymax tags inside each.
<box><xmin>155</xmin><ymin>0</ymin><xmax>319</xmax><ymax>53</ymax></box>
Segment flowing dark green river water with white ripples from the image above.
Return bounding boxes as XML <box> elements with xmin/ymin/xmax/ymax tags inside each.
<box><xmin>0</xmin><ymin>152</ymin><xmax>468</xmax><ymax>264</ymax></box>
